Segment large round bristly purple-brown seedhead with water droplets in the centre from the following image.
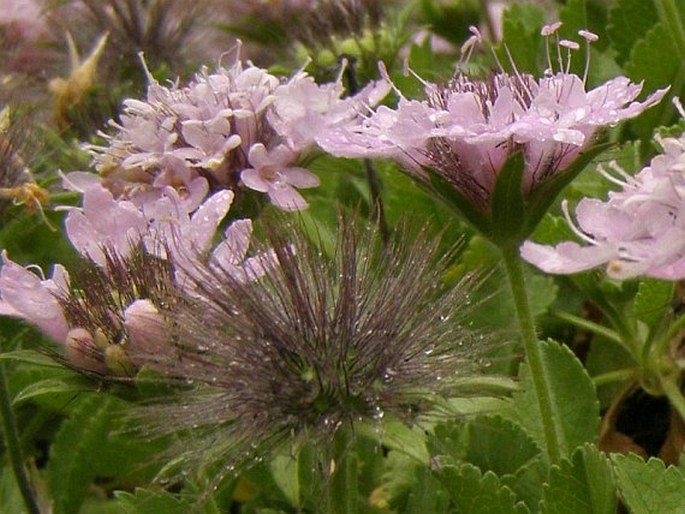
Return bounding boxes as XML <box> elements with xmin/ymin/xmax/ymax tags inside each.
<box><xmin>132</xmin><ymin>215</ymin><xmax>496</xmax><ymax>471</ymax></box>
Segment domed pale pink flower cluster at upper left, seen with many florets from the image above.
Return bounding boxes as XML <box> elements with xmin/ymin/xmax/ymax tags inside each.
<box><xmin>87</xmin><ymin>61</ymin><xmax>388</xmax><ymax>211</ymax></box>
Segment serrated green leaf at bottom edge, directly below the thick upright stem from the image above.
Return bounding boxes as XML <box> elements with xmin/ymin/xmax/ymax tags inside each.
<box><xmin>540</xmin><ymin>445</ymin><xmax>616</xmax><ymax>514</ymax></box>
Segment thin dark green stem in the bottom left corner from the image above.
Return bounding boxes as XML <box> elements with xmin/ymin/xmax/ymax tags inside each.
<box><xmin>0</xmin><ymin>362</ymin><xmax>40</xmax><ymax>514</ymax></box>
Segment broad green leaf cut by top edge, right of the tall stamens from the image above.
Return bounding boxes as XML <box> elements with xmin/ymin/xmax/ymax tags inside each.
<box><xmin>608</xmin><ymin>0</ymin><xmax>659</xmax><ymax>62</ymax></box>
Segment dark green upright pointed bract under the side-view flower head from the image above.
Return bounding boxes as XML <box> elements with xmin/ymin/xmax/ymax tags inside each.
<box><xmin>486</xmin><ymin>152</ymin><xmax>525</xmax><ymax>244</ymax></box>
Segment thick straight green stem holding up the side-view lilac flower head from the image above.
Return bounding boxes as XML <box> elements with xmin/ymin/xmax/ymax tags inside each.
<box><xmin>500</xmin><ymin>244</ymin><xmax>562</xmax><ymax>464</ymax></box>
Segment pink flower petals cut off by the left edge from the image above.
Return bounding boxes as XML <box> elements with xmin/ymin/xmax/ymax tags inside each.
<box><xmin>0</xmin><ymin>251</ymin><xmax>69</xmax><ymax>342</ymax></box>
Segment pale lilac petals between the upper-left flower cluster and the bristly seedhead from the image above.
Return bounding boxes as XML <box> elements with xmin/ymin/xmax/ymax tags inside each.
<box><xmin>60</xmin><ymin>174</ymin><xmax>272</xmax><ymax>282</ymax></box>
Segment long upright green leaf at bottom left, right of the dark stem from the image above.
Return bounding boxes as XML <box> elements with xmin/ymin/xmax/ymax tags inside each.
<box><xmin>47</xmin><ymin>395</ymin><xmax>113</xmax><ymax>514</ymax></box>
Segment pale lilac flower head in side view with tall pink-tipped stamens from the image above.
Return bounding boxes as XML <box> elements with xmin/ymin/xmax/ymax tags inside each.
<box><xmin>320</xmin><ymin>25</ymin><xmax>667</xmax><ymax>212</ymax></box>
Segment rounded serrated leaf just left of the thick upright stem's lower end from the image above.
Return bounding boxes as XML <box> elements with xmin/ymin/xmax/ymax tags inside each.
<box><xmin>464</xmin><ymin>416</ymin><xmax>540</xmax><ymax>476</ymax></box>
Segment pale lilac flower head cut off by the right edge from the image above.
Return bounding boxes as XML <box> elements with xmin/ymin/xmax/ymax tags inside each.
<box><xmin>521</xmin><ymin>128</ymin><xmax>685</xmax><ymax>280</ymax></box>
